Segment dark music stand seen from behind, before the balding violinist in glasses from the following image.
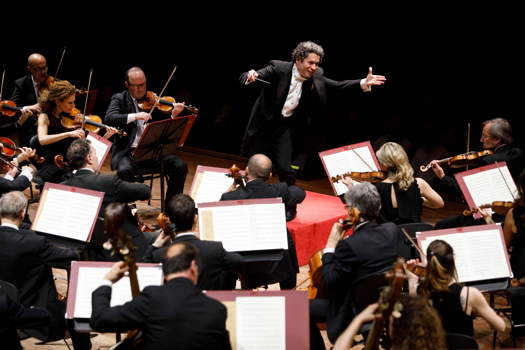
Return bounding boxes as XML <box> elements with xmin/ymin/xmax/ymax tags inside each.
<box><xmin>133</xmin><ymin>114</ymin><xmax>197</xmax><ymax>212</ymax></box>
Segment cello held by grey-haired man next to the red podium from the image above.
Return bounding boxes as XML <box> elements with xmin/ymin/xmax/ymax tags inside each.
<box><xmin>308</xmin><ymin>207</ymin><xmax>361</xmax><ymax>299</ymax></box>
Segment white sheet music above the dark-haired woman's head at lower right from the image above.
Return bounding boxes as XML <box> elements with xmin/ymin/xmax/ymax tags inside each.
<box><xmin>422</xmin><ymin>229</ymin><xmax>511</xmax><ymax>283</ymax></box>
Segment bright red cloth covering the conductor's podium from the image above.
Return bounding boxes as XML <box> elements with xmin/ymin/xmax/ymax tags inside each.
<box><xmin>287</xmin><ymin>191</ymin><xmax>348</xmax><ymax>266</ymax></box>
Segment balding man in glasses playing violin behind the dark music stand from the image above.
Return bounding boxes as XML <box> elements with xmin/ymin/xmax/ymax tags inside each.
<box><xmin>105</xmin><ymin>67</ymin><xmax>188</xmax><ymax>203</ymax></box>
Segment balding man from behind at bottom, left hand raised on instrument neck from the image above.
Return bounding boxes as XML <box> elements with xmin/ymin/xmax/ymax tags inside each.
<box><xmin>90</xmin><ymin>242</ymin><xmax>231</xmax><ymax>350</ymax></box>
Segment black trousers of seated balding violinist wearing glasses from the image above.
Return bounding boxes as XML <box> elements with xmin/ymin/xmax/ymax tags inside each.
<box><xmin>117</xmin><ymin>155</ymin><xmax>188</xmax><ymax>208</ymax></box>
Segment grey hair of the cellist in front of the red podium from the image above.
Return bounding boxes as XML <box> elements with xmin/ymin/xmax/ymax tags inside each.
<box><xmin>345</xmin><ymin>182</ymin><xmax>381</xmax><ymax>220</ymax></box>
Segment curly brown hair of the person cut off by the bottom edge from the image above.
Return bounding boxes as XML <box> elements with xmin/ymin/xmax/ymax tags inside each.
<box><xmin>391</xmin><ymin>296</ymin><xmax>447</xmax><ymax>350</ymax></box>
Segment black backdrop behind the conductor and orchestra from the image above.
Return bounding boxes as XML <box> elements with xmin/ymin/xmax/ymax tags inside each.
<box><xmin>0</xmin><ymin>3</ymin><xmax>525</xmax><ymax>175</ymax></box>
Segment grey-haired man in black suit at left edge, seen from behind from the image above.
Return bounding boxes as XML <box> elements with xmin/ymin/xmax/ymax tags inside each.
<box><xmin>0</xmin><ymin>192</ymin><xmax>91</xmax><ymax>349</ymax></box>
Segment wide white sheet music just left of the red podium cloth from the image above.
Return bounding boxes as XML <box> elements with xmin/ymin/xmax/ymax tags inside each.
<box><xmin>199</xmin><ymin>203</ymin><xmax>288</xmax><ymax>252</ymax></box>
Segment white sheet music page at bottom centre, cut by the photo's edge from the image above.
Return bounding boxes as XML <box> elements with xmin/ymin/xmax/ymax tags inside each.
<box><xmin>236</xmin><ymin>296</ymin><xmax>286</xmax><ymax>350</ymax></box>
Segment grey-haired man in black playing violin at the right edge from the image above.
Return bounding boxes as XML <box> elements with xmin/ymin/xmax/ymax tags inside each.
<box><xmin>430</xmin><ymin>118</ymin><xmax>524</xmax><ymax>229</ymax></box>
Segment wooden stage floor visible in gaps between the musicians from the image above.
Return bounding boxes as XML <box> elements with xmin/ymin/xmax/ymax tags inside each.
<box><xmin>22</xmin><ymin>147</ymin><xmax>525</xmax><ymax>350</ymax></box>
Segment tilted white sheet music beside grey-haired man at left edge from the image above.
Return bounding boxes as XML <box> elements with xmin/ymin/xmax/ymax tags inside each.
<box><xmin>31</xmin><ymin>188</ymin><xmax>102</xmax><ymax>241</ymax></box>
